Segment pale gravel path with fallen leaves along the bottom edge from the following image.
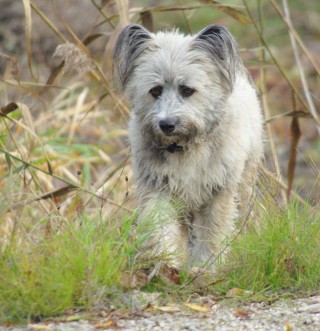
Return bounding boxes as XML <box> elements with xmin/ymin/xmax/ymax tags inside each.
<box><xmin>4</xmin><ymin>296</ymin><xmax>320</xmax><ymax>331</ymax></box>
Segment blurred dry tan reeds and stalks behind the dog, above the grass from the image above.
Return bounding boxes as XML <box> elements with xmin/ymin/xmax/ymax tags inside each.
<box><xmin>0</xmin><ymin>0</ymin><xmax>320</xmax><ymax>209</ymax></box>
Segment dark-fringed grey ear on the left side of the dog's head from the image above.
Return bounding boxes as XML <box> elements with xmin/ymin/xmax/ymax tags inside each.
<box><xmin>113</xmin><ymin>24</ymin><xmax>151</xmax><ymax>88</ymax></box>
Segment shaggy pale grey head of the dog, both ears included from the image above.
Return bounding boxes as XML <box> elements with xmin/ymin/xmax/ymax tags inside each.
<box><xmin>114</xmin><ymin>24</ymin><xmax>241</xmax><ymax>147</ymax></box>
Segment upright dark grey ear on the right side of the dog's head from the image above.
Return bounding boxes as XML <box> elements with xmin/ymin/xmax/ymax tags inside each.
<box><xmin>194</xmin><ymin>24</ymin><xmax>241</xmax><ymax>88</ymax></box>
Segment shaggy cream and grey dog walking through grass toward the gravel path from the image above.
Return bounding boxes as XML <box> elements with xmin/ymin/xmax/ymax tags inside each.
<box><xmin>113</xmin><ymin>24</ymin><xmax>263</xmax><ymax>267</ymax></box>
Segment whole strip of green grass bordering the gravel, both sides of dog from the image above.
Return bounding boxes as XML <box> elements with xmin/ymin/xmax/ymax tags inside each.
<box><xmin>0</xmin><ymin>192</ymin><xmax>320</xmax><ymax>322</ymax></box>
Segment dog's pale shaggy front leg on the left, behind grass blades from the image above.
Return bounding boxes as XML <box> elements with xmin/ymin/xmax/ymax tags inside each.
<box><xmin>138</xmin><ymin>192</ymin><xmax>188</xmax><ymax>268</ymax></box>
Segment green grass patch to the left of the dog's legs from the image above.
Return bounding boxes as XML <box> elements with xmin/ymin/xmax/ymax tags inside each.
<box><xmin>0</xmin><ymin>213</ymin><xmax>134</xmax><ymax>321</ymax></box>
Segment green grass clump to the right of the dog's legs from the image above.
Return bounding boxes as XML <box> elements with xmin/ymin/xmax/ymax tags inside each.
<box><xmin>220</xmin><ymin>202</ymin><xmax>320</xmax><ymax>291</ymax></box>
